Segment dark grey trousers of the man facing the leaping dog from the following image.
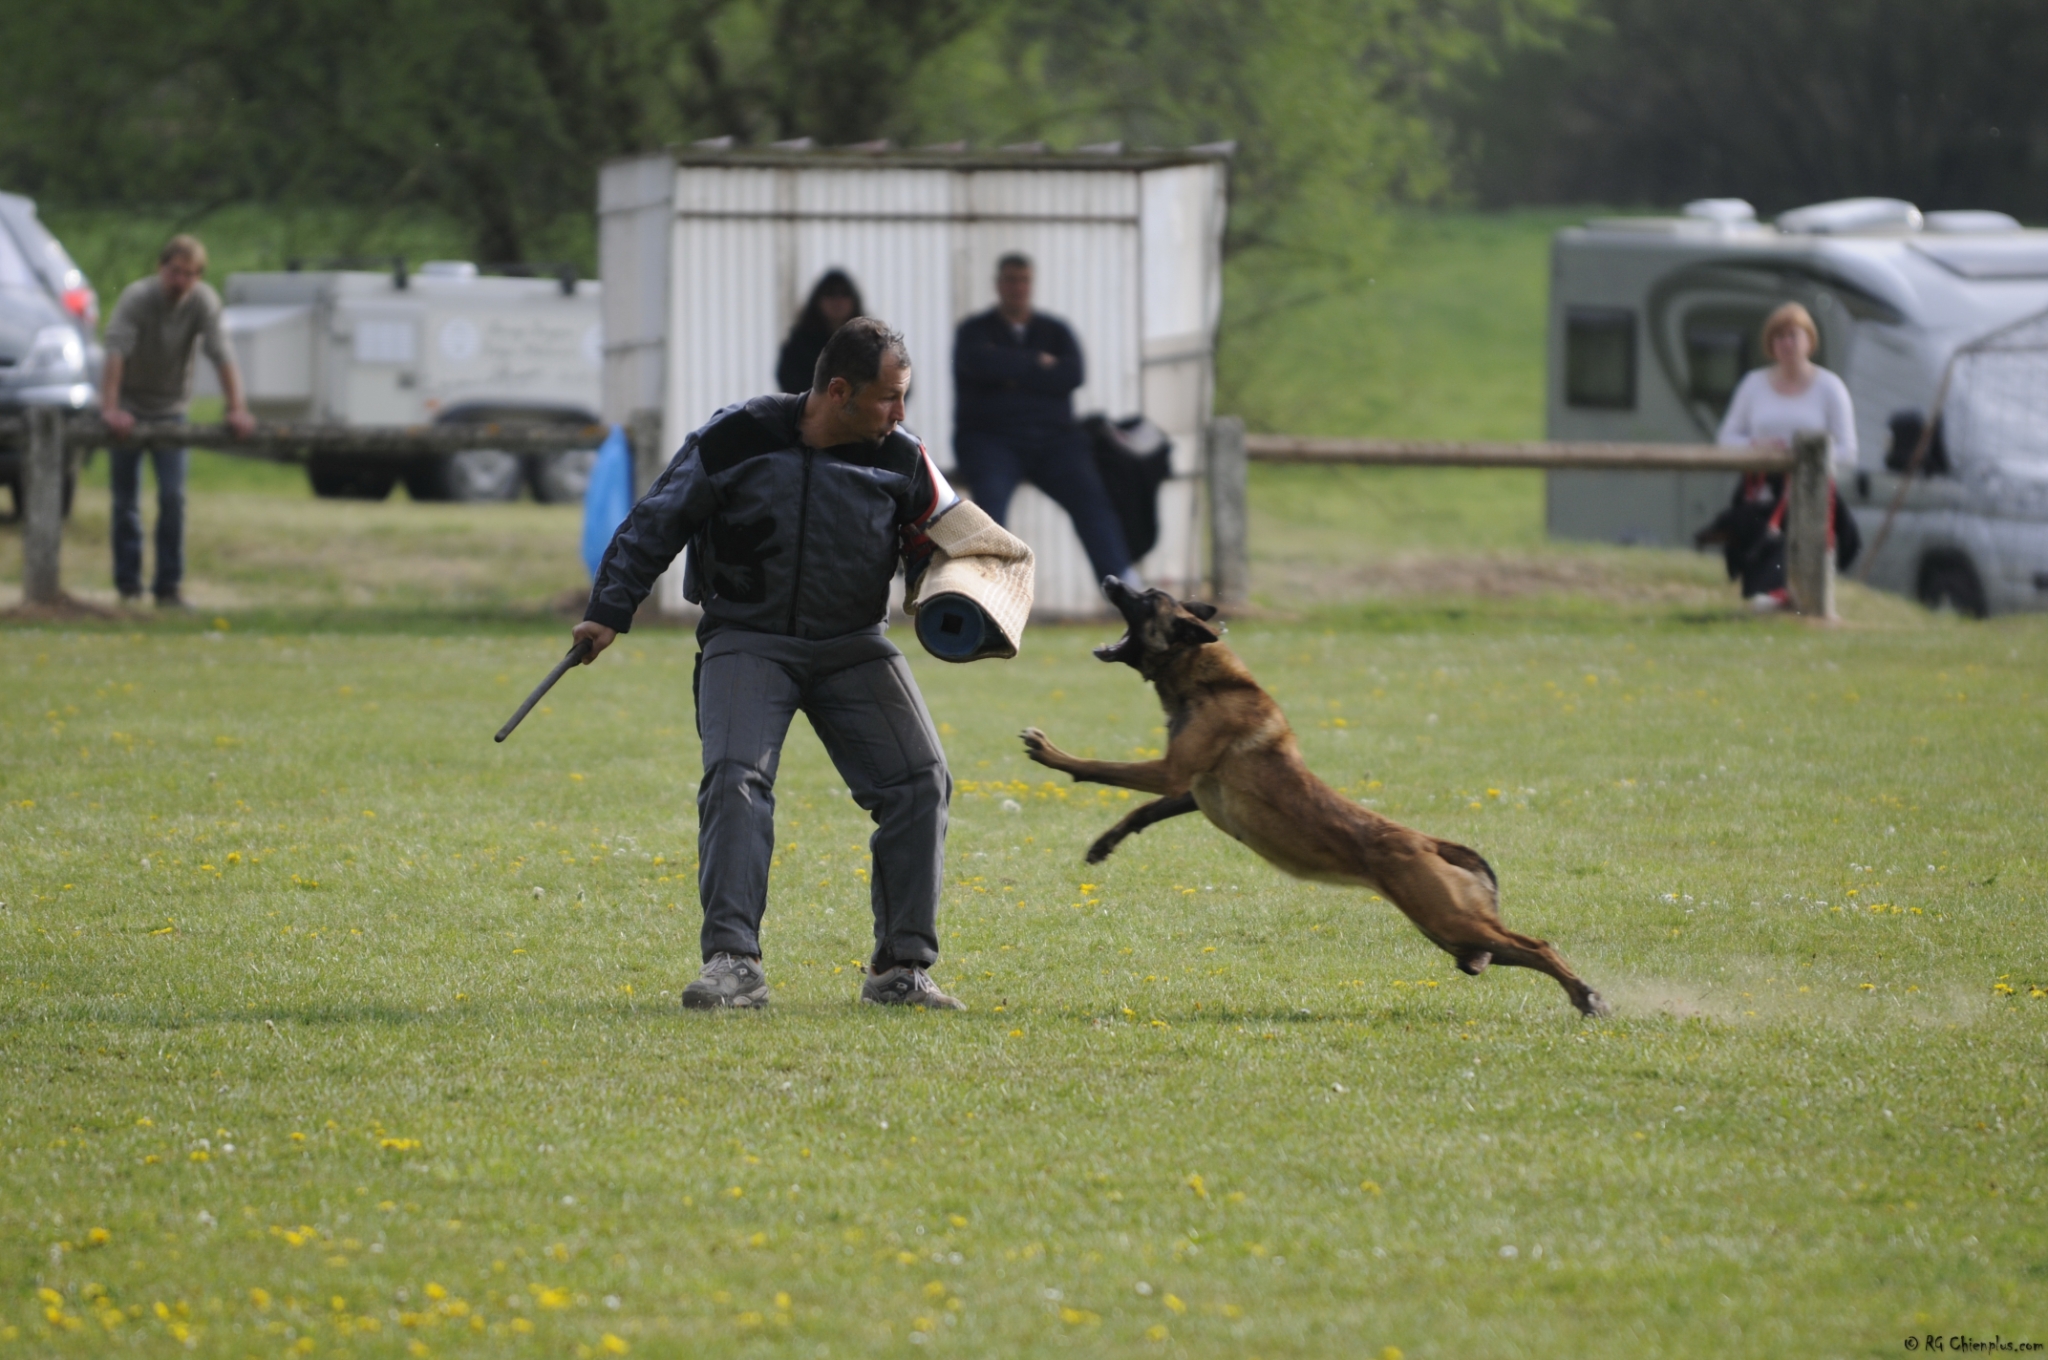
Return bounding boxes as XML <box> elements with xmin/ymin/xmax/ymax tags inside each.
<box><xmin>694</xmin><ymin>627</ymin><xmax>952</xmax><ymax>967</ymax></box>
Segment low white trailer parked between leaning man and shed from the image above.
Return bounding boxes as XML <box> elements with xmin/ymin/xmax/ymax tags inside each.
<box><xmin>197</xmin><ymin>260</ymin><xmax>604</xmax><ymax>502</ymax></box>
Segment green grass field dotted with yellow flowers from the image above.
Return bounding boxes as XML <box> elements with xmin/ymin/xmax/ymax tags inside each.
<box><xmin>0</xmin><ymin>206</ymin><xmax>2048</xmax><ymax>1360</ymax></box>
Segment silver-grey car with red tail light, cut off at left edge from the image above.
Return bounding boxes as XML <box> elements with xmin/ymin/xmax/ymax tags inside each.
<box><xmin>0</xmin><ymin>193</ymin><xmax>100</xmax><ymax>516</ymax></box>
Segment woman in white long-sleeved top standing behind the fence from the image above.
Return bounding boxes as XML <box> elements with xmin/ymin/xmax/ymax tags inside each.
<box><xmin>1702</xmin><ymin>303</ymin><xmax>1862</xmax><ymax>608</ymax></box>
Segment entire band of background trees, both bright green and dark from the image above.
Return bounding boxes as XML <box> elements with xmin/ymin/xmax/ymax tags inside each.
<box><xmin>0</xmin><ymin>0</ymin><xmax>2048</xmax><ymax>270</ymax></box>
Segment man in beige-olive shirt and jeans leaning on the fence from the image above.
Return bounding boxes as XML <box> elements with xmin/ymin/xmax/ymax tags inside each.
<box><xmin>100</xmin><ymin>236</ymin><xmax>256</xmax><ymax>608</ymax></box>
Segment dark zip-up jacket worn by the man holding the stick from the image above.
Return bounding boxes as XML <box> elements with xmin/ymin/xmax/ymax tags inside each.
<box><xmin>584</xmin><ymin>393</ymin><xmax>952</xmax><ymax>641</ymax></box>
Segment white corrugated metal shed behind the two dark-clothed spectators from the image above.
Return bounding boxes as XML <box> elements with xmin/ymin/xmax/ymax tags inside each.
<box><xmin>598</xmin><ymin>147</ymin><xmax>1227</xmax><ymax>617</ymax></box>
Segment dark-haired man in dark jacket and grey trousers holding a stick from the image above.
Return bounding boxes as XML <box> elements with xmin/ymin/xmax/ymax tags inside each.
<box><xmin>575</xmin><ymin>317</ymin><xmax>961</xmax><ymax>1010</ymax></box>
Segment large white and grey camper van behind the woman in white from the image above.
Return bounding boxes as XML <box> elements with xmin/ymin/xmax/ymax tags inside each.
<box><xmin>1546</xmin><ymin>199</ymin><xmax>2048</xmax><ymax>614</ymax></box>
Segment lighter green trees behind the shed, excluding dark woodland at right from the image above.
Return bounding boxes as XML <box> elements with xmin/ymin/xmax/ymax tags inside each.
<box><xmin>0</xmin><ymin>0</ymin><xmax>1575</xmax><ymax>268</ymax></box>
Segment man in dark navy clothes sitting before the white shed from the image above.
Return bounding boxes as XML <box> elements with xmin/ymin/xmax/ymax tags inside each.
<box><xmin>952</xmin><ymin>254</ymin><xmax>1143</xmax><ymax>590</ymax></box>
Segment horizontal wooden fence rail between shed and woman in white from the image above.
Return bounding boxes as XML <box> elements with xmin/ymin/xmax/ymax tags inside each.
<box><xmin>1245</xmin><ymin>434</ymin><xmax>1792</xmax><ymax>473</ymax></box>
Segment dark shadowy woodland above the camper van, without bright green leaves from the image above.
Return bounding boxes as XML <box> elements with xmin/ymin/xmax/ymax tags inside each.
<box><xmin>1444</xmin><ymin>0</ymin><xmax>2048</xmax><ymax>219</ymax></box>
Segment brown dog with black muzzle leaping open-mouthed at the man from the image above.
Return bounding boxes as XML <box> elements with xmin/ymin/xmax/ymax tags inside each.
<box><xmin>1024</xmin><ymin>578</ymin><xmax>1610</xmax><ymax>1016</ymax></box>
